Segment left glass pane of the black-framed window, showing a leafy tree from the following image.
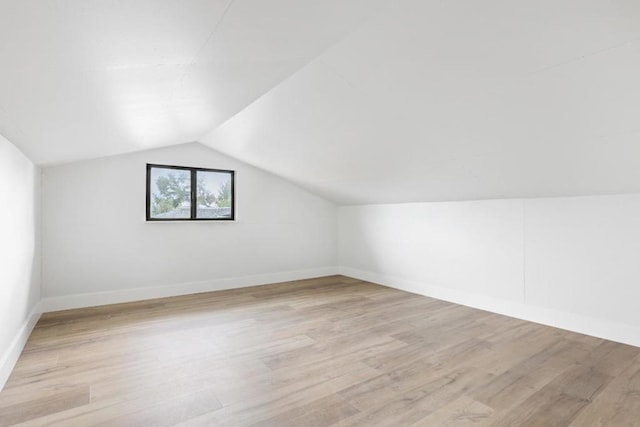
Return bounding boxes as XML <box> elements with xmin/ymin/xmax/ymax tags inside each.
<box><xmin>150</xmin><ymin>167</ymin><xmax>191</xmax><ymax>219</ymax></box>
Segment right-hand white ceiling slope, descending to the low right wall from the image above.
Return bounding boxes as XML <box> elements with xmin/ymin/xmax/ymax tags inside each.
<box><xmin>202</xmin><ymin>0</ymin><xmax>640</xmax><ymax>203</ymax></box>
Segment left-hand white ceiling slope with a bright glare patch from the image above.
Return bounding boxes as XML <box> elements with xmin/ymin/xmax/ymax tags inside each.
<box><xmin>0</xmin><ymin>0</ymin><xmax>388</xmax><ymax>165</ymax></box>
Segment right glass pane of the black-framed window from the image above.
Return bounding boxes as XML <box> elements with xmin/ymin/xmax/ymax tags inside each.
<box><xmin>196</xmin><ymin>171</ymin><xmax>233</xmax><ymax>219</ymax></box>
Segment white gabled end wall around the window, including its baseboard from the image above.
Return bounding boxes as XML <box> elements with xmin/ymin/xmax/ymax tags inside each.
<box><xmin>43</xmin><ymin>143</ymin><xmax>337</xmax><ymax>310</ymax></box>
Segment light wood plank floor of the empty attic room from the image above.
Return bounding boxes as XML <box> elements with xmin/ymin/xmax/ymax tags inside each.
<box><xmin>0</xmin><ymin>276</ymin><xmax>640</xmax><ymax>427</ymax></box>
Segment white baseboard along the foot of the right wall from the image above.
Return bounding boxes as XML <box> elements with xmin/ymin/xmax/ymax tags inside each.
<box><xmin>340</xmin><ymin>267</ymin><xmax>640</xmax><ymax>347</ymax></box>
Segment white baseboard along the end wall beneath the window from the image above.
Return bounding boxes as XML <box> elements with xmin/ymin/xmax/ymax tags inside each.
<box><xmin>42</xmin><ymin>267</ymin><xmax>339</xmax><ymax>313</ymax></box>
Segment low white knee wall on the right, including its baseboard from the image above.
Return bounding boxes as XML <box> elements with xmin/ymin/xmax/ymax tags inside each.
<box><xmin>339</xmin><ymin>195</ymin><xmax>640</xmax><ymax>345</ymax></box>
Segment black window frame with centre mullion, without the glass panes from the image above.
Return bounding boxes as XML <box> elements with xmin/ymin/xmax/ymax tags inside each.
<box><xmin>146</xmin><ymin>163</ymin><xmax>236</xmax><ymax>222</ymax></box>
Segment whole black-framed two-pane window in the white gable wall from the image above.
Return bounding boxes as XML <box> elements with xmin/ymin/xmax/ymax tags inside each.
<box><xmin>147</xmin><ymin>164</ymin><xmax>235</xmax><ymax>221</ymax></box>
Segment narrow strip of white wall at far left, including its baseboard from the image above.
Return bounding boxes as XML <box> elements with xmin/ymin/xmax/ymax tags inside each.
<box><xmin>0</xmin><ymin>136</ymin><xmax>41</xmax><ymax>389</ymax></box>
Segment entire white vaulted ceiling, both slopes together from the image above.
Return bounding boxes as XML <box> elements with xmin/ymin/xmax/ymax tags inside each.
<box><xmin>0</xmin><ymin>0</ymin><xmax>640</xmax><ymax>203</ymax></box>
